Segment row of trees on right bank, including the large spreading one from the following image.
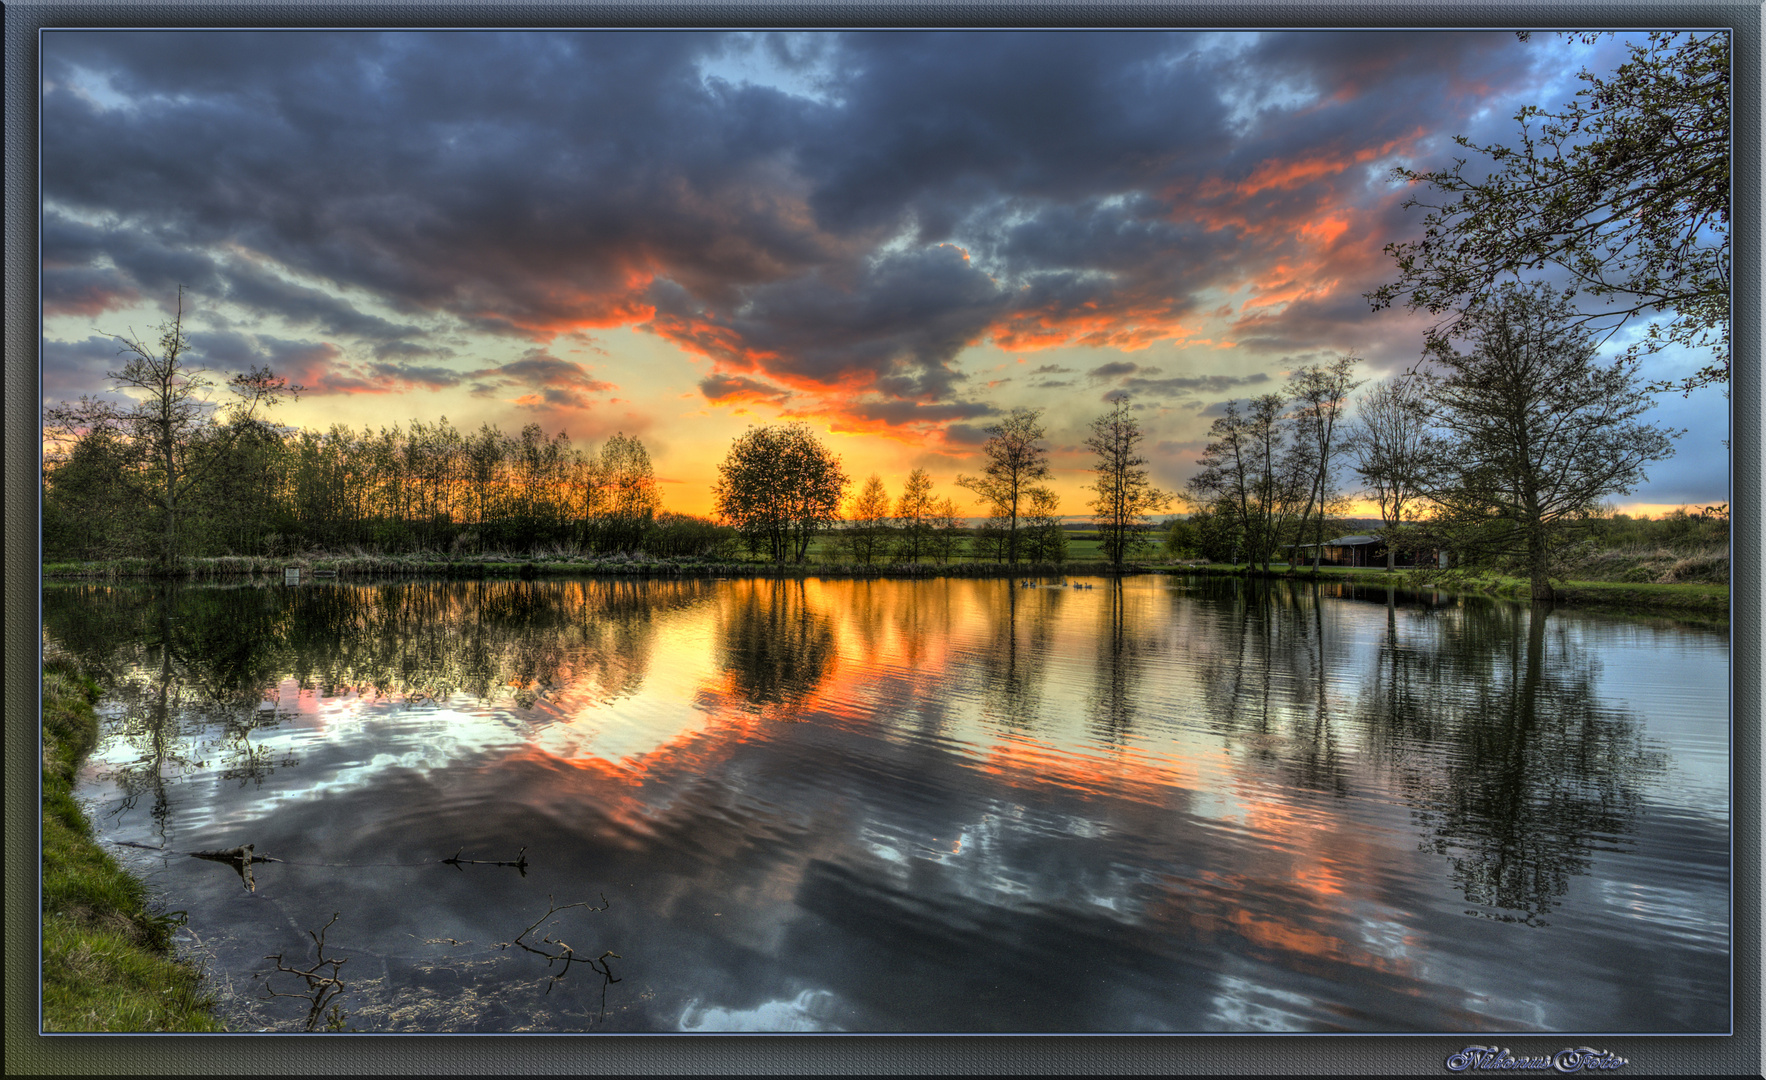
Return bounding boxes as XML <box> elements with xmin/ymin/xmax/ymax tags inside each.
<box><xmin>1189</xmin><ymin>284</ymin><xmax>1681</xmax><ymax>598</ymax></box>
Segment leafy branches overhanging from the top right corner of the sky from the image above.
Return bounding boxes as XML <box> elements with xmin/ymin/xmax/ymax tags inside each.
<box><xmin>1367</xmin><ymin>32</ymin><xmax>1731</xmax><ymax>394</ymax></box>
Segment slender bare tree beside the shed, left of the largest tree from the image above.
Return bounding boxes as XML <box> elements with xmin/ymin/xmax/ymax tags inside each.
<box><xmin>1347</xmin><ymin>376</ymin><xmax>1438</xmax><ymax>570</ymax></box>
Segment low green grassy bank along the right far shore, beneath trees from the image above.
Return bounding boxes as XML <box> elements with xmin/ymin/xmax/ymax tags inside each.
<box><xmin>1155</xmin><ymin>563</ymin><xmax>1729</xmax><ymax>619</ymax></box>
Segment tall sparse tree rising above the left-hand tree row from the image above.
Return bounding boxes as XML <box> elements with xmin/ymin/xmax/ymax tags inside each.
<box><xmin>44</xmin><ymin>286</ymin><xmax>302</xmax><ymax>572</ymax></box>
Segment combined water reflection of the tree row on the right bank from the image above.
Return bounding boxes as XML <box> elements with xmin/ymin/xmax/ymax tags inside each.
<box><xmin>1197</xmin><ymin>582</ymin><xmax>1665</xmax><ymax>925</ymax></box>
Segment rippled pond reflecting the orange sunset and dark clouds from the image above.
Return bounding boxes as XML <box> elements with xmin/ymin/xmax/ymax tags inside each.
<box><xmin>42</xmin><ymin>575</ymin><xmax>1731</xmax><ymax>1034</ymax></box>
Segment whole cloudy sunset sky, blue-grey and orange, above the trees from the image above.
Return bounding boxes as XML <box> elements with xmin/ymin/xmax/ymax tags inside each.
<box><xmin>41</xmin><ymin>30</ymin><xmax>1729</xmax><ymax>517</ymax></box>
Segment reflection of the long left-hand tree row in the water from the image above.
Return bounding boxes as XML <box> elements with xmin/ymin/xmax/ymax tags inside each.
<box><xmin>42</xmin><ymin>581</ymin><xmax>688</xmax><ymax>825</ymax></box>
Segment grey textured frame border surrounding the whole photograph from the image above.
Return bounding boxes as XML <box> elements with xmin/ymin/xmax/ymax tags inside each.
<box><xmin>4</xmin><ymin>0</ymin><xmax>1766</xmax><ymax>1075</ymax></box>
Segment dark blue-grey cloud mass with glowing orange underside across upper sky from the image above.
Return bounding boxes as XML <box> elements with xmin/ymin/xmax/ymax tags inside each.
<box><xmin>42</xmin><ymin>32</ymin><xmax>1575</xmax><ymax>425</ymax></box>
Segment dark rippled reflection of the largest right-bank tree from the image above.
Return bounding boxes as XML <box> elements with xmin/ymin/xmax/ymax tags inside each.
<box><xmin>1358</xmin><ymin>602</ymin><xmax>1667</xmax><ymax>925</ymax></box>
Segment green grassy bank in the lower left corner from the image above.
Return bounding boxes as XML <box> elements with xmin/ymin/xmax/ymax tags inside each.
<box><xmin>42</xmin><ymin>662</ymin><xmax>223</xmax><ymax>1031</ymax></box>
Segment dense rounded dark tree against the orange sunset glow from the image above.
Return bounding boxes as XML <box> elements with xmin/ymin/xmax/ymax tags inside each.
<box><xmin>712</xmin><ymin>422</ymin><xmax>846</xmax><ymax>563</ymax></box>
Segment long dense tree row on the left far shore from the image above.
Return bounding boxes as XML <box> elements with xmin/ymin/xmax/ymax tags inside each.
<box><xmin>42</xmin><ymin>293</ymin><xmax>728</xmax><ymax>566</ymax></box>
